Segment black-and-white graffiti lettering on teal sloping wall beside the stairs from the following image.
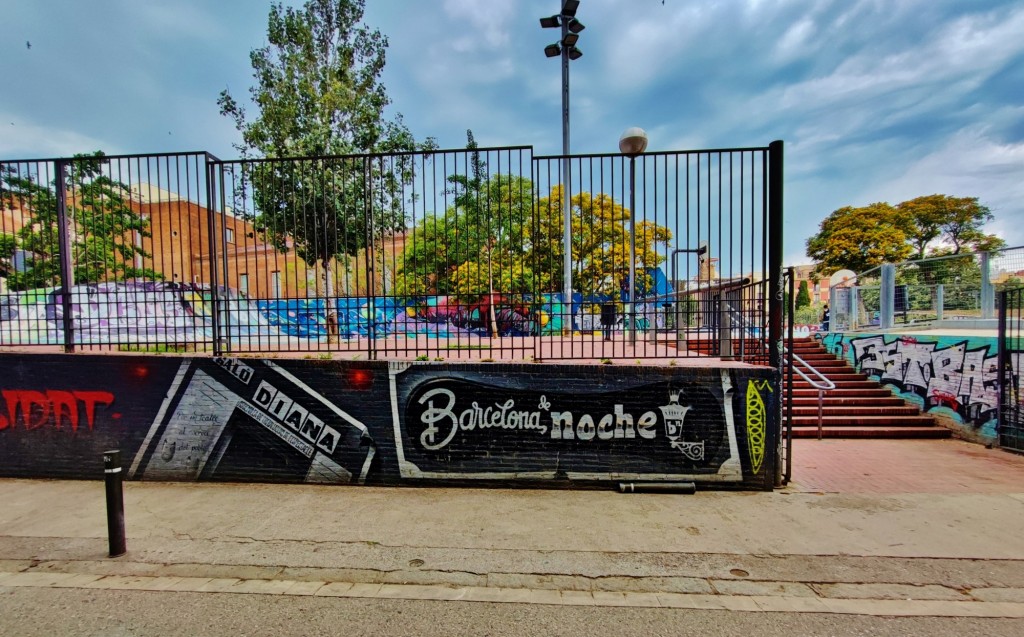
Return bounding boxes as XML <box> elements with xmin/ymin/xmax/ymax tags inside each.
<box><xmin>822</xmin><ymin>333</ymin><xmax>1024</xmax><ymax>435</ymax></box>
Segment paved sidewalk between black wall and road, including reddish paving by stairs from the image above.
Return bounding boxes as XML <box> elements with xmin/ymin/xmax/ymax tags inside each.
<box><xmin>0</xmin><ymin>440</ymin><xmax>1024</xmax><ymax>618</ymax></box>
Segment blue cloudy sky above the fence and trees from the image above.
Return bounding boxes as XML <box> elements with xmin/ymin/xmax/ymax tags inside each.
<box><xmin>0</xmin><ymin>0</ymin><xmax>1024</xmax><ymax>264</ymax></box>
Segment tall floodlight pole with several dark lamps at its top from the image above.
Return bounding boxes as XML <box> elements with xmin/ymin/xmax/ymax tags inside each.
<box><xmin>541</xmin><ymin>0</ymin><xmax>586</xmax><ymax>325</ymax></box>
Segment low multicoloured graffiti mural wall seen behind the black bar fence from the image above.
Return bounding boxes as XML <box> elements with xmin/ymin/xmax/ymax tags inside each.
<box><xmin>0</xmin><ymin>275</ymin><xmax>669</xmax><ymax>348</ymax></box>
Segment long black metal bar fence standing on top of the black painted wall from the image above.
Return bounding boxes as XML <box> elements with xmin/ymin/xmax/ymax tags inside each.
<box><xmin>0</xmin><ymin>142</ymin><xmax>782</xmax><ymax>367</ymax></box>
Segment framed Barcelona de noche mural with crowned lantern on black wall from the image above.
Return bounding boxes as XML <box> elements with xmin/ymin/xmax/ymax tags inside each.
<box><xmin>390</xmin><ymin>363</ymin><xmax>742</xmax><ymax>481</ymax></box>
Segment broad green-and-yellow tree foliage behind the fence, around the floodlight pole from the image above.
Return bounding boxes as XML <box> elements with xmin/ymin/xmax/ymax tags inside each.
<box><xmin>398</xmin><ymin>184</ymin><xmax>672</xmax><ymax>296</ymax></box>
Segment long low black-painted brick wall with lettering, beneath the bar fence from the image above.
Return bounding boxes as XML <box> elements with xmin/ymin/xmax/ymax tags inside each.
<box><xmin>0</xmin><ymin>354</ymin><xmax>778</xmax><ymax>489</ymax></box>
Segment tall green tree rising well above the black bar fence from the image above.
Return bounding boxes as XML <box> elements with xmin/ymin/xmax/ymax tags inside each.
<box><xmin>218</xmin><ymin>0</ymin><xmax>435</xmax><ymax>297</ymax></box>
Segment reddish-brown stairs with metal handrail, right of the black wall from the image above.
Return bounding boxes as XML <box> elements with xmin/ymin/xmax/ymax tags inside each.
<box><xmin>782</xmin><ymin>338</ymin><xmax>951</xmax><ymax>438</ymax></box>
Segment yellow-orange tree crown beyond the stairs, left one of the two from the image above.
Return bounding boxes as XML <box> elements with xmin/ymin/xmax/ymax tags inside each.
<box><xmin>807</xmin><ymin>203</ymin><xmax>913</xmax><ymax>274</ymax></box>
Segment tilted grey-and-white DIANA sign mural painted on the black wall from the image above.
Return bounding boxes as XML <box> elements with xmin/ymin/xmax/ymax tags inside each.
<box><xmin>130</xmin><ymin>358</ymin><xmax>374</xmax><ymax>483</ymax></box>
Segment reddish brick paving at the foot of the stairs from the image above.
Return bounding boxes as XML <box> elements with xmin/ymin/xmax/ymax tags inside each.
<box><xmin>788</xmin><ymin>439</ymin><xmax>1024</xmax><ymax>494</ymax></box>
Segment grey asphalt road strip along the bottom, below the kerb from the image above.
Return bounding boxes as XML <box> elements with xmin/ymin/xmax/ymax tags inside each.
<box><xmin>0</xmin><ymin>587</ymin><xmax>1024</xmax><ymax>637</ymax></box>
